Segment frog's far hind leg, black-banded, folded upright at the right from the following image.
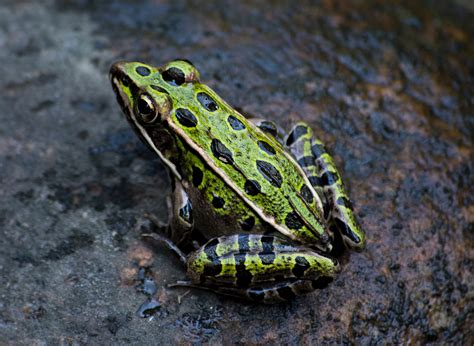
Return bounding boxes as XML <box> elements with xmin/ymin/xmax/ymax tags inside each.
<box><xmin>286</xmin><ymin>122</ymin><xmax>365</xmax><ymax>249</ymax></box>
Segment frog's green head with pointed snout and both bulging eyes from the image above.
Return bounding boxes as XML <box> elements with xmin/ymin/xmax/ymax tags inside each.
<box><xmin>110</xmin><ymin>60</ymin><xmax>199</xmax><ymax>129</ymax></box>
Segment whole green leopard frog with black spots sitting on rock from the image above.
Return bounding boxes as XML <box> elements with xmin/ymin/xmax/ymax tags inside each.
<box><xmin>109</xmin><ymin>59</ymin><xmax>366</xmax><ymax>303</ymax></box>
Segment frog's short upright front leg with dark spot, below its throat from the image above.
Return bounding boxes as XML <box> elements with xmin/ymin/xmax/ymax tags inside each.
<box><xmin>168</xmin><ymin>180</ymin><xmax>194</xmax><ymax>244</ymax></box>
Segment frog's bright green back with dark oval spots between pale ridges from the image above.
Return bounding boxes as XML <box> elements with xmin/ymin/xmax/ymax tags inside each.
<box><xmin>168</xmin><ymin>83</ymin><xmax>327</xmax><ymax>249</ymax></box>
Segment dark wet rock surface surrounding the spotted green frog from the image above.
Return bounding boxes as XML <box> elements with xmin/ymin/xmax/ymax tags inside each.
<box><xmin>0</xmin><ymin>0</ymin><xmax>474</xmax><ymax>344</ymax></box>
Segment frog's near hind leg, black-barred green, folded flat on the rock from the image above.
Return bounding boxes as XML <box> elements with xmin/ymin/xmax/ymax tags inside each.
<box><xmin>187</xmin><ymin>234</ymin><xmax>339</xmax><ymax>303</ymax></box>
